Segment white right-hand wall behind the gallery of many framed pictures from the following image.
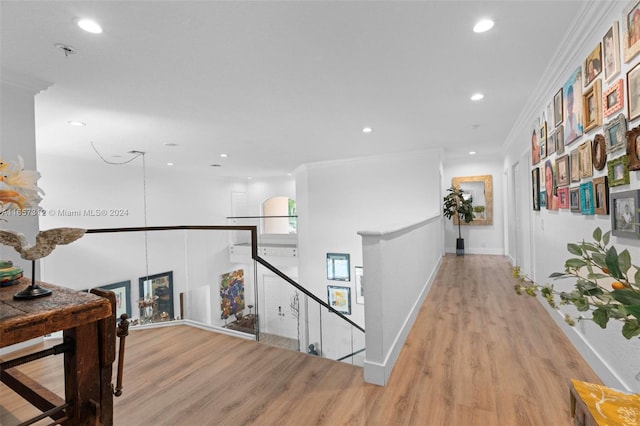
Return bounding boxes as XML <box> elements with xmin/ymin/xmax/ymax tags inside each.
<box><xmin>503</xmin><ymin>2</ymin><xmax>640</xmax><ymax>392</ymax></box>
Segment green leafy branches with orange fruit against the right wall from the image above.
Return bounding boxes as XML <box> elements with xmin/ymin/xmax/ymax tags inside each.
<box><xmin>513</xmin><ymin>228</ymin><xmax>640</xmax><ymax>339</ymax></box>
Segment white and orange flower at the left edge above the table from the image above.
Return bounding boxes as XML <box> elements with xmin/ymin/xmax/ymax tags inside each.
<box><xmin>0</xmin><ymin>156</ymin><xmax>44</xmax><ymax>214</ymax></box>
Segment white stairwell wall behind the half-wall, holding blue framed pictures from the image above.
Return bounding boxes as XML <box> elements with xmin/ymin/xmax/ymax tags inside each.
<box><xmin>296</xmin><ymin>151</ymin><xmax>440</xmax><ymax>357</ymax></box>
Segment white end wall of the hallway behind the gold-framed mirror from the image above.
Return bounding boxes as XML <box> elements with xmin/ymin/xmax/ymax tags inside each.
<box><xmin>442</xmin><ymin>156</ymin><xmax>504</xmax><ymax>255</ymax></box>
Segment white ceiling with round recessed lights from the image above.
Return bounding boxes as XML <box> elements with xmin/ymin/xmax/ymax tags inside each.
<box><xmin>0</xmin><ymin>0</ymin><xmax>581</xmax><ymax>177</ymax></box>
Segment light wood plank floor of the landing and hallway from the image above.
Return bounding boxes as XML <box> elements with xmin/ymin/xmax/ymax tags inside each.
<box><xmin>0</xmin><ymin>255</ymin><xmax>600</xmax><ymax>426</ymax></box>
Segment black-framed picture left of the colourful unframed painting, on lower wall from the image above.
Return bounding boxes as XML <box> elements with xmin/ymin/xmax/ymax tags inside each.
<box><xmin>138</xmin><ymin>271</ymin><xmax>174</xmax><ymax>322</ymax></box>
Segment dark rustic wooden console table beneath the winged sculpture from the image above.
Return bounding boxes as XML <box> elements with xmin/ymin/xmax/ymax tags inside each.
<box><xmin>0</xmin><ymin>278</ymin><xmax>116</xmax><ymax>425</ymax></box>
